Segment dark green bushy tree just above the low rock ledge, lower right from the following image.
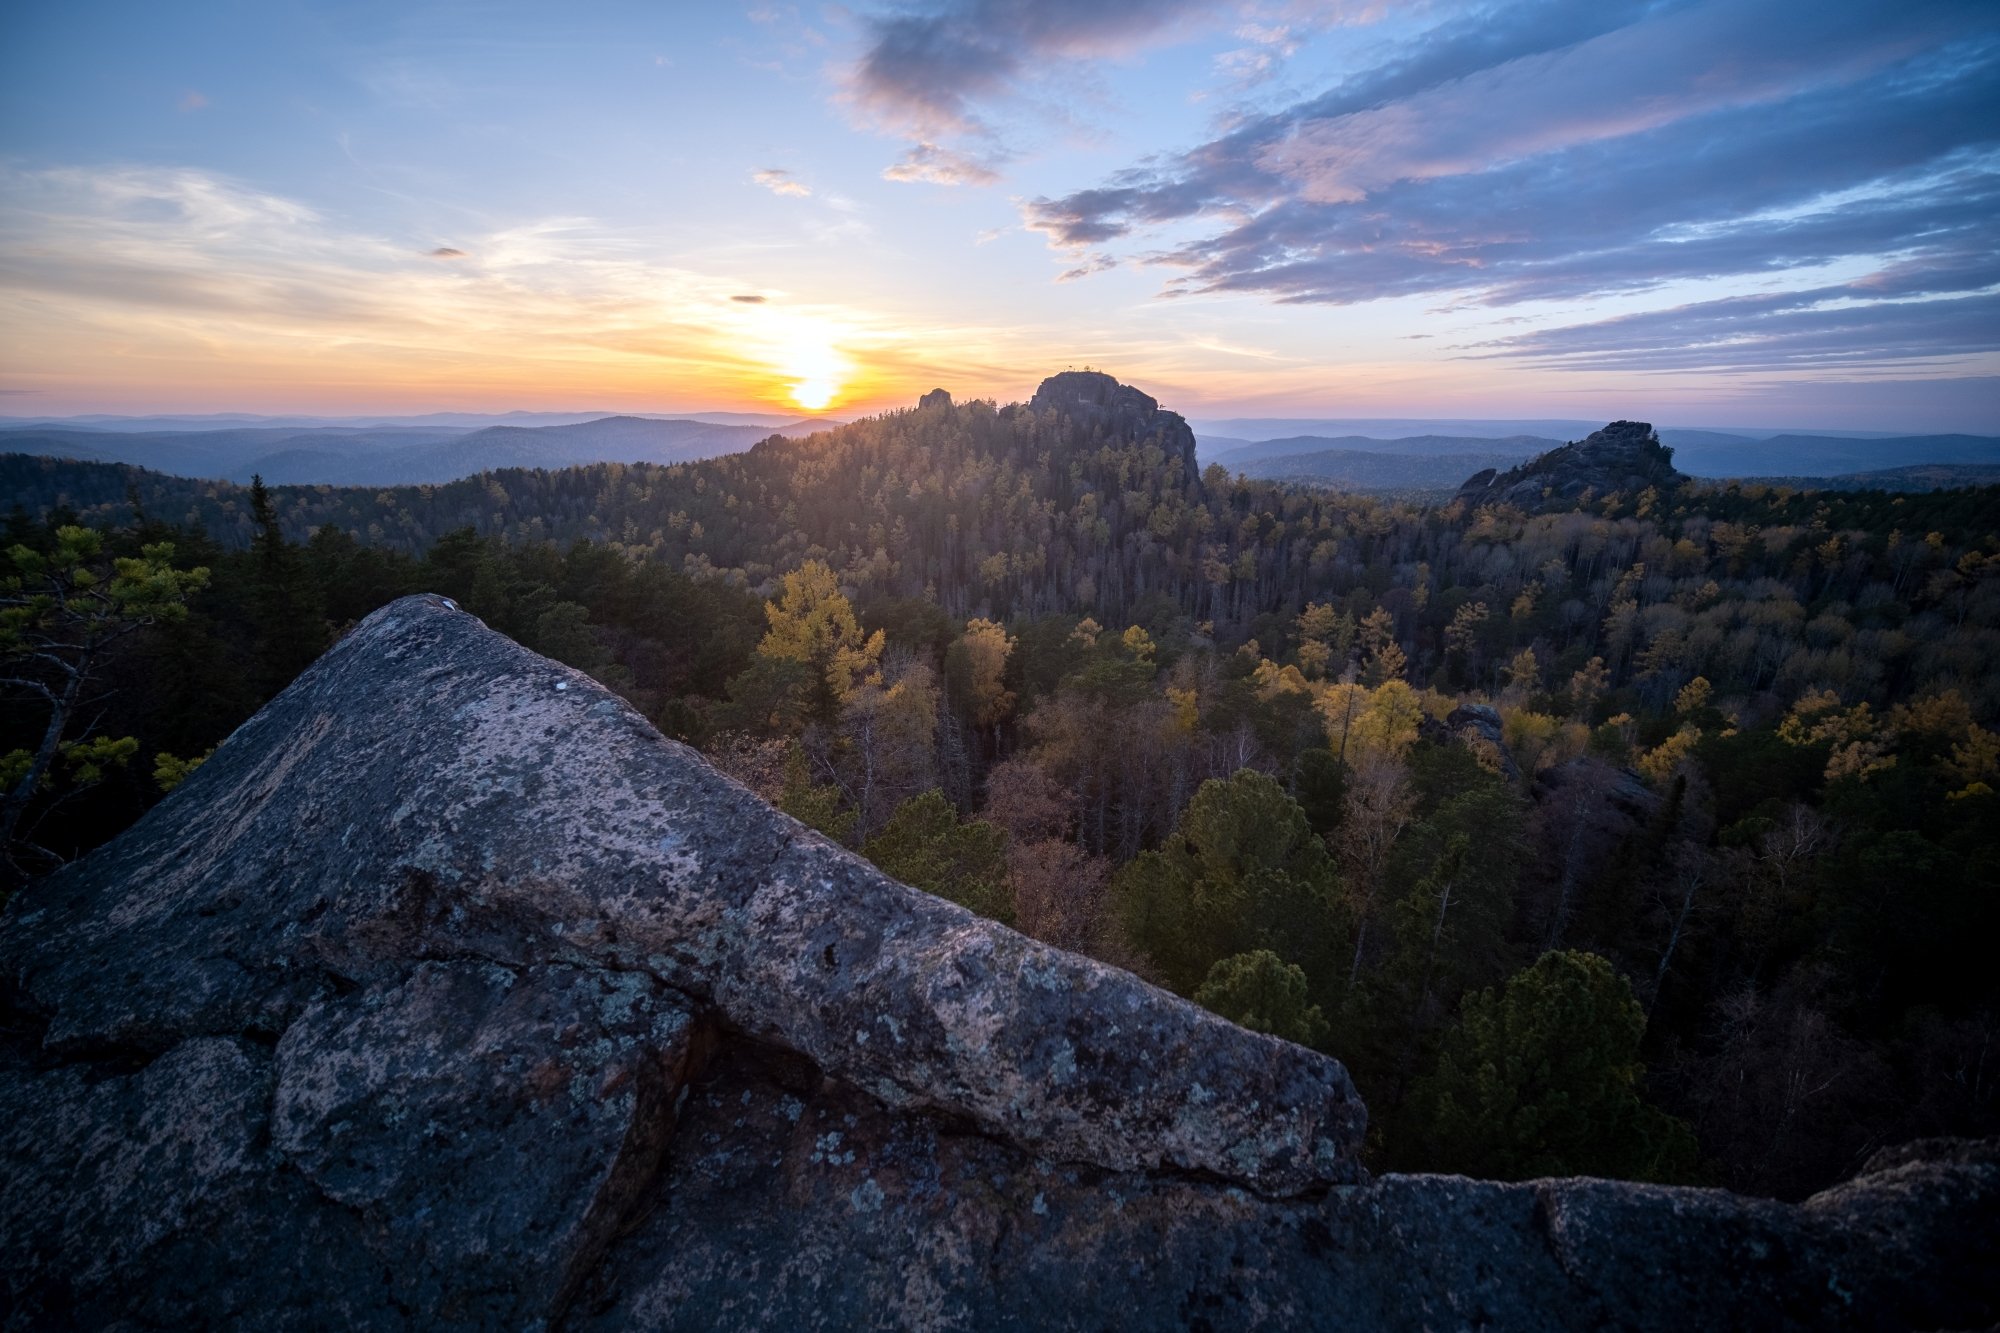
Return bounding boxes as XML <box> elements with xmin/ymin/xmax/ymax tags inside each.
<box><xmin>1416</xmin><ymin>951</ymin><xmax>1694</xmax><ymax>1181</ymax></box>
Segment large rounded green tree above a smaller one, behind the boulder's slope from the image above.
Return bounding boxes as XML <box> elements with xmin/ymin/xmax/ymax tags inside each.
<box><xmin>1112</xmin><ymin>769</ymin><xmax>1348</xmax><ymax>995</ymax></box>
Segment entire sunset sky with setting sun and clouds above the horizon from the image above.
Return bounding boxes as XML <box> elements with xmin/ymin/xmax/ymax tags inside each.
<box><xmin>0</xmin><ymin>0</ymin><xmax>2000</xmax><ymax>432</ymax></box>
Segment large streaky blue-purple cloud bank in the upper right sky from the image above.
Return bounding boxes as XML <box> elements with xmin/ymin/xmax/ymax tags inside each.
<box><xmin>1022</xmin><ymin>0</ymin><xmax>2000</xmax><ymax>366</ymax></box>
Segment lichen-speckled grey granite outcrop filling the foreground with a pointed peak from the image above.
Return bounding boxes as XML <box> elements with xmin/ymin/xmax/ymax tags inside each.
<box><xmin>0</xmin><ymin>598</ymin><xmax>2000</xmax><ymax>1329</ymax></box>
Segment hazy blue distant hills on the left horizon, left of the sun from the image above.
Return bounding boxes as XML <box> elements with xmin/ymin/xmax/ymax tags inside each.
<box><xmin>0</xmin><ymin>416</ymin><xmax>818</xmax><ymax>486</ymax></box>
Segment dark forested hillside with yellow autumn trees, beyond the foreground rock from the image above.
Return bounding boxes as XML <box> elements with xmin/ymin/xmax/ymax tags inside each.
<box><xmin>0</xmin><ymin>374</ymin><xmax>2000</xmax><ymax>1195</ymax></box>
